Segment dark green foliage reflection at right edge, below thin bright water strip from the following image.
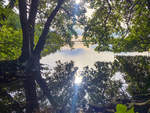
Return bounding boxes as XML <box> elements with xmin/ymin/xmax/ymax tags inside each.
<box><xmin>114</xmin><ymin>56</ymin><xmax>150</xmax><ymax>99</ymax></box>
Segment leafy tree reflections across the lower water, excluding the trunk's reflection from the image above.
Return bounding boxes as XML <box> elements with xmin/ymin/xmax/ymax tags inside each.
<box><xmin>0</xmin><ymin>57</ymin><xmax>150</xmax><ymax>113</ymax></box>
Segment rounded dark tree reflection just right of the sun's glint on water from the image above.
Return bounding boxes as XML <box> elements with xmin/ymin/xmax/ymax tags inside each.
<box><xmin>83</xmin><ymin>62</ymin><xmax>122</xmax><ymax>104</ymax></box>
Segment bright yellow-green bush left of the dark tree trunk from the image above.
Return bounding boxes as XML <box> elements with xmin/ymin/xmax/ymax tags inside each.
<box><xmin>0</xmin><ymin>21</ymin><xmax>22</xmax><ymax>60</ymax></box>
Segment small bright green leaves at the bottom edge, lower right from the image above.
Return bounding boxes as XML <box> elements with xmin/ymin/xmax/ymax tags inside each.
<box><xmin>115</xmin><ymin>104</ymin><xmax>135</xmax><ymax>113</ymax></box>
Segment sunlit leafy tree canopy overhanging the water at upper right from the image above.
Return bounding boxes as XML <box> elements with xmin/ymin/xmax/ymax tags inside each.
<box><xmin>83</xmin><ymin>0</ymin><xmax>150</xmax><ymax>52</ymax></box>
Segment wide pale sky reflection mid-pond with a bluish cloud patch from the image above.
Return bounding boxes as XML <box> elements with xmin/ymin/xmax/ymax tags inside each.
<box><xmin>41</xmin><ymin>43</ymin><xmax>114</xmax><ymax>69</ymax></box>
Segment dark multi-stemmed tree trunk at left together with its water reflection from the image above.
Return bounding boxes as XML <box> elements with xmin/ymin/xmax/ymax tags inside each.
<box><xmin>19</xmin><ymin>0</ymin><xmax>64</xmax><ymax>113</ymax></box>
